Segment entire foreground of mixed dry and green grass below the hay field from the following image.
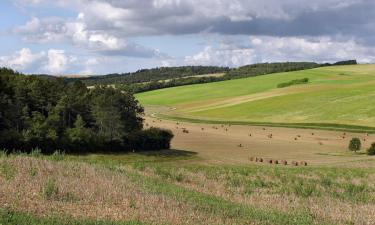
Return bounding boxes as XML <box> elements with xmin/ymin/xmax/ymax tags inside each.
<box><xmin>0</xmin><ymin>151</ymin><xmax>375</xmax><ymax>224</ymax></box>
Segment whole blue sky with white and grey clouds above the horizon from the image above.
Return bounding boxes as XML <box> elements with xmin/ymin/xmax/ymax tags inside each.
<box><xmin>0</xmin><ymin>0</ymin><xmax>375</xmax><ymax>75</ymax></box>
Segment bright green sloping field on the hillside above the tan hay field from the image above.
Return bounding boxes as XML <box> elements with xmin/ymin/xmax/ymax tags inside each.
<box><xmin>137</xmin><ymin>65</ymin><xmax>375</xmax><ymax>127</ymax></box>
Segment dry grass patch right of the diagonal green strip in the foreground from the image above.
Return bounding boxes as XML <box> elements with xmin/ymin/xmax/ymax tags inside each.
<box><xmin>134</xmin><ymin>163</ymin><xmax>375</xmax><ymax>224</ymax></box>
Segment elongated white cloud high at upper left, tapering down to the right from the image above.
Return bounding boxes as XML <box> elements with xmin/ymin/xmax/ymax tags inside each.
<box><xmin>14</xmin><ymin>13</ymin><xmax>161</xmax><ymax>58</ymax></box>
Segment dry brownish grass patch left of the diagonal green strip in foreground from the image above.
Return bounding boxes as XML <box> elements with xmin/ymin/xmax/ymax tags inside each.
<box><xmin>0</xmin><ymin>157</ymin><xmax>232</xmax><ymax>224</ymax></box>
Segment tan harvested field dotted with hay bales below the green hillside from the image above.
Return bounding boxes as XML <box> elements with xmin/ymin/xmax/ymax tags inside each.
<box><xmin>146</xmin><ymin>117</ymin><xmax>375</xmax><ymax>166</ymax></box>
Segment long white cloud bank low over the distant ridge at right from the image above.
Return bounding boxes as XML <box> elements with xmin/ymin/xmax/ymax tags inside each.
<box><xmin>184</xmin><ymin>36</ymin><xmax>375</xmax><ymax>67</ymax></box>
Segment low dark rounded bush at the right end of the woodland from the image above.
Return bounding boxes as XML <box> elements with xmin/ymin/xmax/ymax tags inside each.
<box><xmin>129</xmin><ymin>128</ymin><xmax>174</xmax><ymax>151</ymax></box>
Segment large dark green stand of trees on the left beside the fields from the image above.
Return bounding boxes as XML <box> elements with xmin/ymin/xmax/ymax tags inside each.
<box><xmin>0</xmin><ymin>68</ymin><xmax>173</xmax><ymax>153</ymax></box>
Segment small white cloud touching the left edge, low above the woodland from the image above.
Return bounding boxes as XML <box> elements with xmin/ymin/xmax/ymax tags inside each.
<box><xmin>0</xmin><ymin>48</ymin><xmax>45</xmax><ymax>70</ymax></box>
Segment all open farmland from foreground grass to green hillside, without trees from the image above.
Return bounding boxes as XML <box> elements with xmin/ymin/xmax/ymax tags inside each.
<box><xmin>0</xmin><ymin>65</ymin><xmax>375</xmax><ymax>225</ymax></box>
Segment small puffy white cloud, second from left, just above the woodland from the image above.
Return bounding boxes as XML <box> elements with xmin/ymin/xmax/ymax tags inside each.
<box><xmin>44</xmin><ymin>49</ymin><xmax>68</xmax><ymax>75</ymax></box>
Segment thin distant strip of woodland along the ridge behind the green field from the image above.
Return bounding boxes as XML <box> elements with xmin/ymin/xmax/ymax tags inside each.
<box><xmin>73</xmin><ymin>60</ymin><xmax>357</xmax><ymax>93</ymax></box>
